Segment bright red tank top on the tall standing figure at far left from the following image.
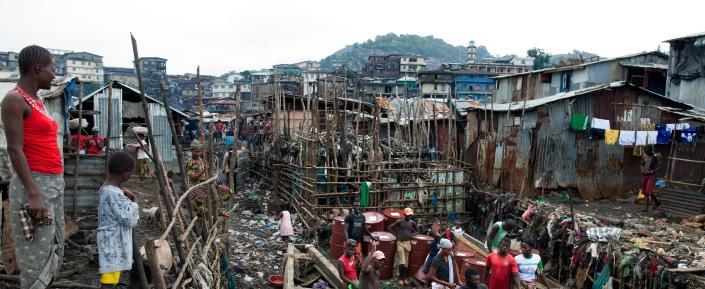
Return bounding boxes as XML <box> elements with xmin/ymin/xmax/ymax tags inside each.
<box><xmin>12</xmin><ymin>86</ymin><xmax>64</xmax><ymax>175</ymax></box>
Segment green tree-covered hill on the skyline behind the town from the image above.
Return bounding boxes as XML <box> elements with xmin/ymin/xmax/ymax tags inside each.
<box><xmin>321</xmin><ymin>33</ymin><xmax>491</xmax><ymax>71</ymax></box>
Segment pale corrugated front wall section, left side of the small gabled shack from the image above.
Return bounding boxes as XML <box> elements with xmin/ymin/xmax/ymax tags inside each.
<box><xmin>93</xmin><ymin>88</ymin><xmax>122</xmax><ymax>149</ymax></box>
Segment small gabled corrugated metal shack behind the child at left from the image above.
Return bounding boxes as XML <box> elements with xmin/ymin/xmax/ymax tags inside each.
<box><xmin>73</xmin><ymin>81</ymin><xmax>188</xmax><ymax>172</ymax></box>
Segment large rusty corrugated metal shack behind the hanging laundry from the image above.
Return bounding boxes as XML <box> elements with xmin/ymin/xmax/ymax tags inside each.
<box><xmin>465</xmin><ymin>81</ymin><xmax>690</xmax><ymax>199</ymax></box>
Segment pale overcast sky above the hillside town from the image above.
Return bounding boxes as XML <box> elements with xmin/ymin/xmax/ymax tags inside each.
<box><xmin>0</xmin><ymin>0</ymin><xmax>705</xmax><ymax>75</ymax></box>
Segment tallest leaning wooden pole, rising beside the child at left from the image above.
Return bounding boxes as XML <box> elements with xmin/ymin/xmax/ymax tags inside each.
<box><xmin>130</xmin><ymin>33</ymin><xmax>185</xmax><ymax>265</ymax></box>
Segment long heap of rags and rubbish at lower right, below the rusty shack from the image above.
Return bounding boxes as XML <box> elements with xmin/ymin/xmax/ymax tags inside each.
<box><xmin>469</xmin><ymin>192</ymin><xmax>705</xmax><ymax>288</ymax></box>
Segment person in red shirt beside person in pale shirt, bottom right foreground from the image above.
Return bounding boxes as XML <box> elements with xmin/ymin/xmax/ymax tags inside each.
<box><xmin>485</xmin><ymin>238</ymin><xmax>521</xmax><ymax>289</ymax></box>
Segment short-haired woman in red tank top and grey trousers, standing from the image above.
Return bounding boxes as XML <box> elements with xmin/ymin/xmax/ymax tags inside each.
<box><xmin>0</xmin><ymin>45</ymin><xmax>64</xmax><ymax>288</ymax></box>
